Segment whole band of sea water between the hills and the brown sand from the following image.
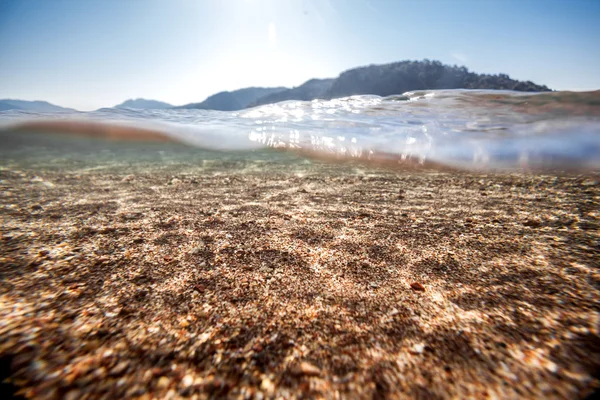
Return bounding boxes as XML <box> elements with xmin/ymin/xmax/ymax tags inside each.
<box><xmin>0</xmin><ymin>90</ymin><xmax>600</xmax><ymax>171</ymax></box>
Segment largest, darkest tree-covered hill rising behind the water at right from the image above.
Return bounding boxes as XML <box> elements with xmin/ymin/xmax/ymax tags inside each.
<box><xmin>250</xmin><ymin>60</ymin><xmax>550</xmax><ymax>106</ymax></box>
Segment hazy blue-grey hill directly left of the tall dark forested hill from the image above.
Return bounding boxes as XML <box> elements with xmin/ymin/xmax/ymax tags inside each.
<box><xmin>176</xmin><ymin>87</ymin><xmax>287</xmax><ymax>111</ymax></box>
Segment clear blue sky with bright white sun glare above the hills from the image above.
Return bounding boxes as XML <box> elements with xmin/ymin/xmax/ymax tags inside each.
<box><xmin>0</xmin><ymin>0</ymin><xmax>600</xmax><ymax>110</ymax></box>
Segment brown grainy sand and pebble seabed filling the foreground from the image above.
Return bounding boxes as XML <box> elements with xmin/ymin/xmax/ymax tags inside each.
<box><xmin>0</xmin><ymin>161</ymin><xmax>600</xmax><ymax>399</ymax></box>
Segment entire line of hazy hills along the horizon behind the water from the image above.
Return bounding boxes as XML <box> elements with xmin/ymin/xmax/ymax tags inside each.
<box><xmin>0</xmin><ymin>59</ymin><xmax>551</xmax><ymax>111</ymax></box>
